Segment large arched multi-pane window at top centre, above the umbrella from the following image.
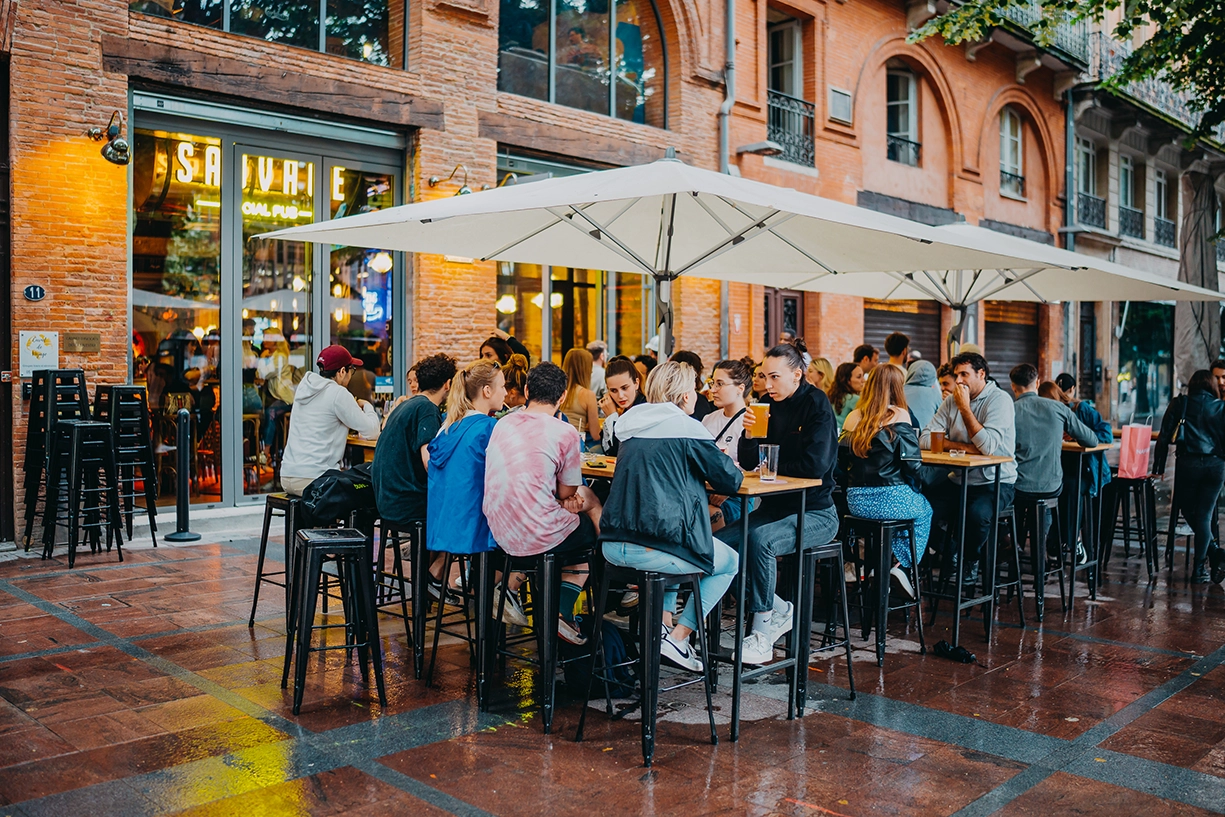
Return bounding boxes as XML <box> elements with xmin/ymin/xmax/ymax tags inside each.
<box><xmin>497</xmin><ymin>0</ymin><xmax>668</xmax><ymax>127</ymax></box>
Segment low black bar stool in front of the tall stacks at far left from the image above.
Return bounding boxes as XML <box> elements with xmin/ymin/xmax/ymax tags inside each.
<box><xmin>43</xmin><ymin>420</ymin><xmax>124</xmax><ymax>567</ymax></box>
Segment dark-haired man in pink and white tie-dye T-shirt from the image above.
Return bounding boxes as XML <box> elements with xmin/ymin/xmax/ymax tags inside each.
<box><xmin>484</xmin><ymin>363</ymin><xmax>600</xmax><ymax>643</ymax></box>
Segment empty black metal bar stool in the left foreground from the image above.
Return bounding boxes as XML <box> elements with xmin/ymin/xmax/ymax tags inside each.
<box><xmin>281</xmin><ymin>528</ymin><xmax>387</xmax><ymax>715</ymax></box>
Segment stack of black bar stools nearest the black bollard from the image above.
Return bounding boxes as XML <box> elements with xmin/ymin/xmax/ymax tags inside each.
<box><xmin>93</xmin><ymin>386</ymin><xmax>157</xmax><ymax>548</ymax></box>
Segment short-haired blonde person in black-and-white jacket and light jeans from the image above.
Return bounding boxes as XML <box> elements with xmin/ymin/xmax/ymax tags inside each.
<box><xmin>600</xmin><ymin>361</ymin><xmax>744</xmax><ymax>672</ymax></box>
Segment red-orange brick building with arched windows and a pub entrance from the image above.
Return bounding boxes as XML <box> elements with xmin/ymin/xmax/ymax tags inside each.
<box><xmin>0</xmin><ymin>0</ymin><xmax>1107</xmax><ymax>524</ymax></box>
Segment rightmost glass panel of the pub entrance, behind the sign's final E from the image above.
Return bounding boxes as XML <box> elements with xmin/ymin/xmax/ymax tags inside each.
<box><xmin>328</xmin><ymin>165</ymin><xmax>396</xmax><ymax>408</ymax></box>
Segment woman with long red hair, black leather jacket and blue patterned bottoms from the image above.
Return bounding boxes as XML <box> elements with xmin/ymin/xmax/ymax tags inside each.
<box><xmin>842</xmin><ymin>366</ymin><xmax>931</xmax><ymax>597</ymax></box>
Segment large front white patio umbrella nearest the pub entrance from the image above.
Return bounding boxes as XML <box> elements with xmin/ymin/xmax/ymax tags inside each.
<box><xmin>260</xmin><ymin>158</ymin><xmax>1033</xmax><ymax>353</ymax></box>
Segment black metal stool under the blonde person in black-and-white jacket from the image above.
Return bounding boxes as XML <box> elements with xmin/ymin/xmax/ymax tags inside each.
<box><xmin>575</xmin><ymin>562</ymin><xmax>719</xmax><ymax>768</ymax></box>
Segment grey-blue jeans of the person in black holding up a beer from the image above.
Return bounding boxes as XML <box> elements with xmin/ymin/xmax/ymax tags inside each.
<box><xmin>719</xmin><ymin>506</ymin><xmax>838</xmax><ymax>614</ymax></box>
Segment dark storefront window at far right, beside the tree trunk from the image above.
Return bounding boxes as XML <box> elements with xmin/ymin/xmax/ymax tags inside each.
<box><xmin>1118</xmin><ymin>301</ymin><xmax>1174</xmax><ymax>425</ymax></box>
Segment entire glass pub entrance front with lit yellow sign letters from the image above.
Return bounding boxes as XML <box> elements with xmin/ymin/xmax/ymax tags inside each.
<box><xmin>130</xmin><ymin>115</ymin><xmax>408</xmax><ymax>505</ymax></box>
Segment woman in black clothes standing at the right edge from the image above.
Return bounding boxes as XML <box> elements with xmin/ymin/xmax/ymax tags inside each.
<box><xmin>1154</xmin><ymin>369</ymin><xmax>1225</xmax><ymax>584</ymax></box>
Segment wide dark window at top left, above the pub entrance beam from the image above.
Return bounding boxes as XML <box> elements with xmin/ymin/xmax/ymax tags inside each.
<box><xmin>127</xmin><ymin>0</ymin><xmax>407</xmax><ymax>69</ymax></box>
